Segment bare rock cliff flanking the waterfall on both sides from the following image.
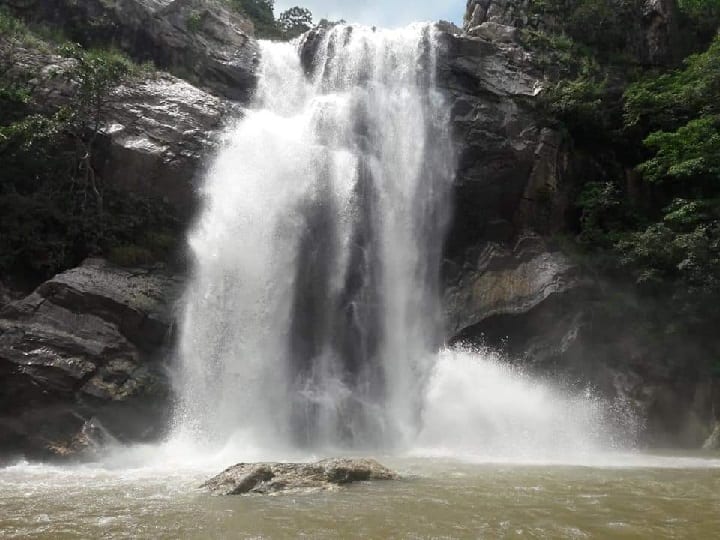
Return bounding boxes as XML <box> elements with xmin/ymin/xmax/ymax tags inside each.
<box><xmin>0</xmin><ymin>0</ymin><xmax>713</xmax><ymax>456</ymax></box>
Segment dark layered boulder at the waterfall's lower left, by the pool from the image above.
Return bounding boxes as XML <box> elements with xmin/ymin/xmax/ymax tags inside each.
<box><xmin>0</xmin><ymin>259</ymin><xmax>181</xmax><ymax>457</ymax></box>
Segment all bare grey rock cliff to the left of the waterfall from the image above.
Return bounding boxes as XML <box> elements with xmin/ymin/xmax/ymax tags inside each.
<box><xmin>0</xmin><ymin>1</ymin><xmax>257</xmax><ymax>458</ymax></box>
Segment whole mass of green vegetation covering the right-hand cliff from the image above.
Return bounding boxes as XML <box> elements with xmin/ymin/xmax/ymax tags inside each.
<box><xmin>522</xmin><ymin>0</ymin><xmax>720</xmax><ymax>342</ymax></box>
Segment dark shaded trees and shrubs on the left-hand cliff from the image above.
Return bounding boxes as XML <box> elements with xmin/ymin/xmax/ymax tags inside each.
<box><xmin>0</xmin><ymin>16</ymin><xmax>177</xmax><ymax>280</ymax></box>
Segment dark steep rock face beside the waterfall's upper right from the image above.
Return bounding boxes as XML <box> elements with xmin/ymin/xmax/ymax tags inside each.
<box><xmin>438</xmin><ymin>30</ymin><xmax>570</xmax><ymax>262</ymax></box>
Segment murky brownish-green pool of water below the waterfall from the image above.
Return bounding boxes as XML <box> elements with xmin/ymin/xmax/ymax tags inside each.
<box><xmin>0</xmin><ymin>454</ymin><xmax>720</xmax><ymax>539</ymax></box>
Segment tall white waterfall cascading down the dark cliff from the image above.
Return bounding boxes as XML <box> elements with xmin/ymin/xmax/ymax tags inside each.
<box><xmin>175</xmin><ymin>25</ymin><xmax>453</xmax><ymax>449</ymax></box>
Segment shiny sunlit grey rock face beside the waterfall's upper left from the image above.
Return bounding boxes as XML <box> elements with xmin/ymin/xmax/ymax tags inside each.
<box><xmin>99</xmin><ymin>75</ymin><xmax>240</xmax><ymax>219</ymax></box>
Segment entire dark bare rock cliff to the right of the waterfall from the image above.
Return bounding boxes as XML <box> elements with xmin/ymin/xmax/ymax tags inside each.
<box><xmin>440</xmin><ymin>0</ymin><xmax>718</xmax><ymax>447</ymax></box>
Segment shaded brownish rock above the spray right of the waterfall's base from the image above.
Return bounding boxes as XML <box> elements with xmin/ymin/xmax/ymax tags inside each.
<box><xmin>445</xmin><ymin>244</ymin><xmax>714</xmax><ymax>448</ymax></box>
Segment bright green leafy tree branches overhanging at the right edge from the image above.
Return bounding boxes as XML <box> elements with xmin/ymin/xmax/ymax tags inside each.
<box><xmin>617</xmin><ymin>36</ymin><xmax>720</xmax><ymax>329</ymax></box>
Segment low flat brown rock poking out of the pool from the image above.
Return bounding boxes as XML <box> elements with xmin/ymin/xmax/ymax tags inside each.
<box><xmin>201</xmin><ymin>459</ymin><xmax>399</xmax><ymax>495</ymax></box>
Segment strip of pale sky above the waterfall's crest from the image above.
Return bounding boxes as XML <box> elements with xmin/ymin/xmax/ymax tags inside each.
<box><xmin>275</xmin><ymin>0</ymin><xmax>466</xmax><ymax>28</ymax></box>
